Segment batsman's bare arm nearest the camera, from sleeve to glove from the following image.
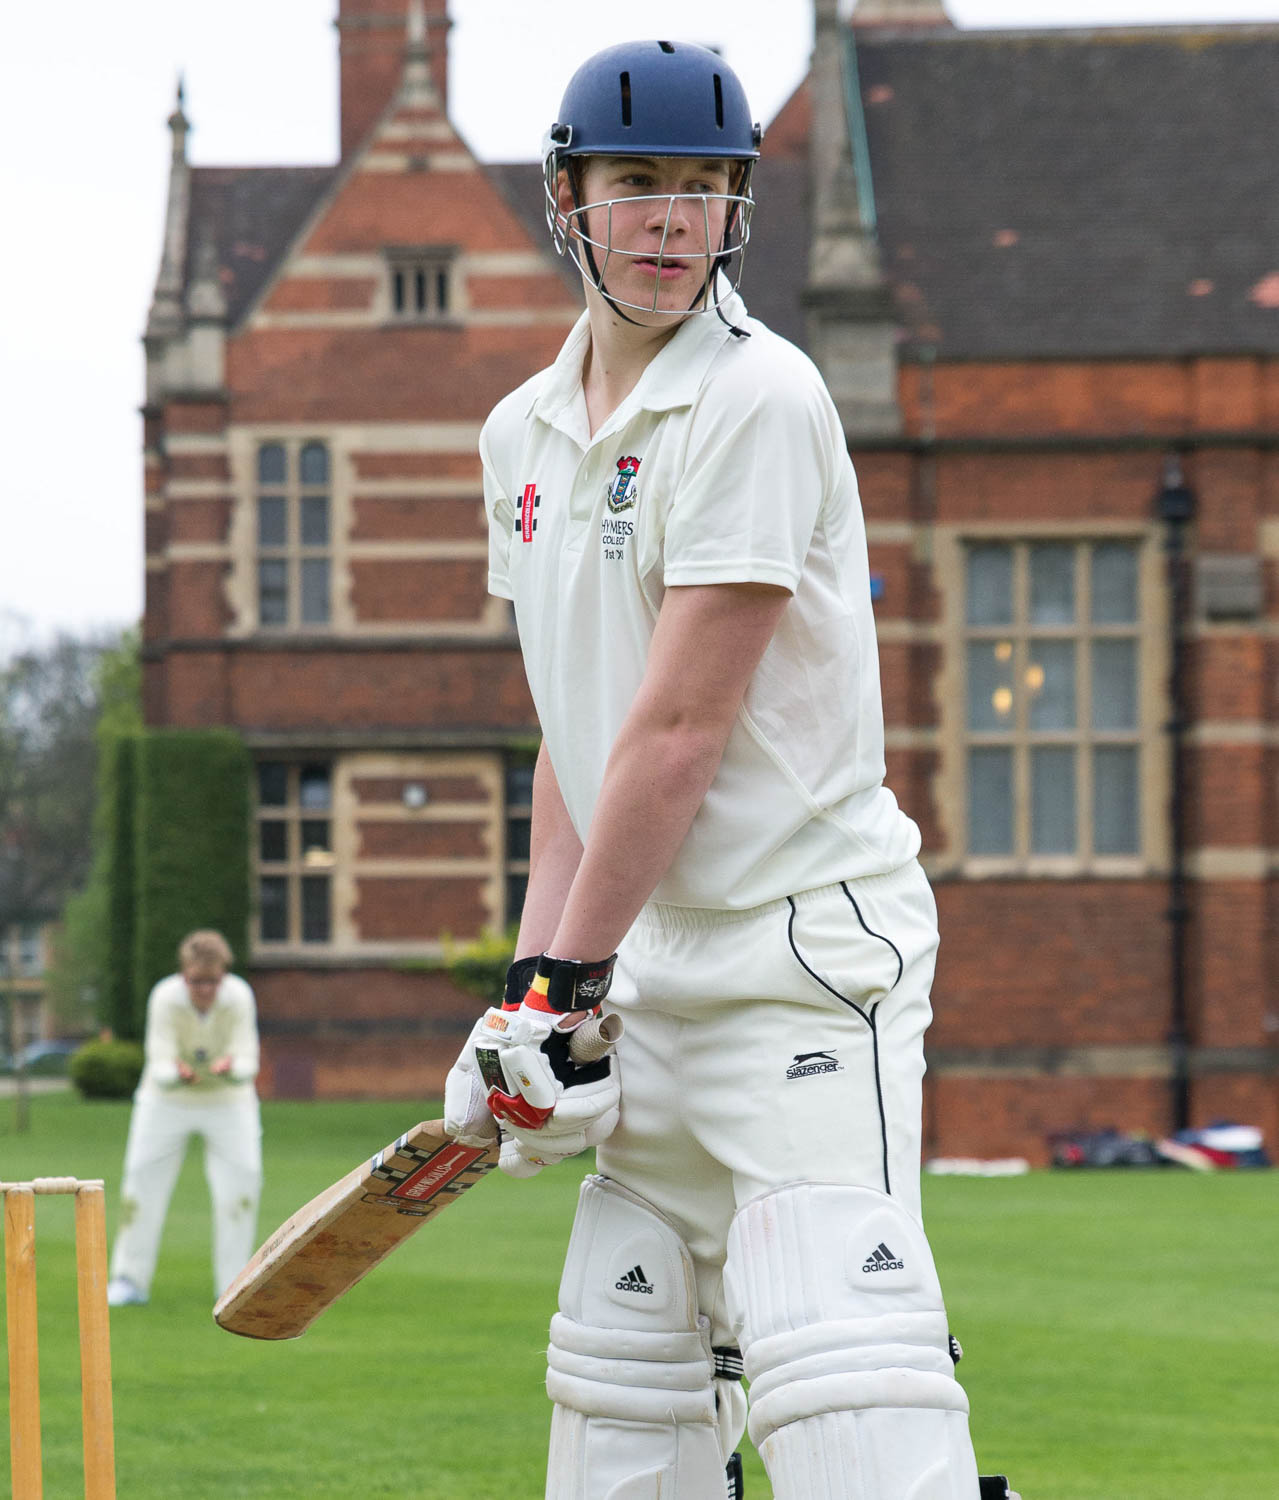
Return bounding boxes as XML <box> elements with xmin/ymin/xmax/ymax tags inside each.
<box><xmin>547</xmin><ymin>584</ymin><xmax>790</xmax><ymax>959</ymax></box>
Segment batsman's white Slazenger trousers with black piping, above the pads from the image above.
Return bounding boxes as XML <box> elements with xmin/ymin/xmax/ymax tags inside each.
<box><xmin>597</xmin><ymin>861</ymin><xmax>937</xmax><ymax>1344</ymax></box>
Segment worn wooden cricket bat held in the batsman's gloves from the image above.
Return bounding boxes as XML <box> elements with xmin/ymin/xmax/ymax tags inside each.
<box><xmin>213</xmin><ymin>1016</ymin><xmax>622</xmax><ymax>1338</ymax></box>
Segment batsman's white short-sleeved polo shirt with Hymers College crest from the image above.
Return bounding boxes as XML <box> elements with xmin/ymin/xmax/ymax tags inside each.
<box><xmin>480</xmin><ymin>286</ymin><xmax>919</xmax><ymax>909</ymax></box>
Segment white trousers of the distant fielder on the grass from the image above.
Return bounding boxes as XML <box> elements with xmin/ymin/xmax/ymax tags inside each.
<box><xmin>111</xmin><ymin>1086</ymin><xmax>262</xmax><ymax>1298</ymax></box>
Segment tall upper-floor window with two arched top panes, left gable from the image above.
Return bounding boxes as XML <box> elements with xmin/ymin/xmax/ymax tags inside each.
<box><xmin>256</xmin><ymin>443</ymin><xmax>331</xmax><ymax>629</ymax></box>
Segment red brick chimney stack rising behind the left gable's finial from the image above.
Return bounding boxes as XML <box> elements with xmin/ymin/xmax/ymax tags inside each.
<box><xmin>336</xmin><ymin>0</ymin><xmax>453</xmax><ymax>161</ymax></box>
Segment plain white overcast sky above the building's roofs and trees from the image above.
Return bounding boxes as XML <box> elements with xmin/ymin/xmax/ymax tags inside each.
<box><xmin>0</xmin><ymin>0</ymin><xmax>1279</xmax><ymax>654</ymax></box>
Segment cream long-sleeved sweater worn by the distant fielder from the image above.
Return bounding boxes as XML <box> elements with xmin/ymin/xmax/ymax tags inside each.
<box><xmin>138</xmin><ymin>974</ymin><xmax>258</xmax><ymax>1103</ymax></box>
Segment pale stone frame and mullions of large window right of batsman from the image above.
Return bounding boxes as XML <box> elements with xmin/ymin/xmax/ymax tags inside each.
<box><xmin>930</xmin><ymin>521</ymin><xmax>1170</xmax><ymax>879</ymax></box>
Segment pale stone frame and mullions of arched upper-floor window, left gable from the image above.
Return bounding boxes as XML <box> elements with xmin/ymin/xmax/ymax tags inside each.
<box><xmin>250</xmin><ymin>434</ymin><xmax>339</xmax><ymax>635</ymax></box>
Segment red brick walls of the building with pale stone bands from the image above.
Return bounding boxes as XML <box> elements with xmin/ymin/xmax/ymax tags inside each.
<box><xmin>144</xmin><ymin>17</ymin><xmax>1279</xmax><ymax>1161</ymax></box>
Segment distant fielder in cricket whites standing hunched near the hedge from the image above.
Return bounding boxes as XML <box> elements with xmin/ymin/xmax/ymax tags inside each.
<box><xmin>106</xmin><ymin>932</ymin><xmax>262</xmax><ymax>1307</ymax></box>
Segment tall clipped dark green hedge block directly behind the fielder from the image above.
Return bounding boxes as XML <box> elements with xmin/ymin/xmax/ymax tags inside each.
<box><xmin>132</xmin><ymin>729</ymin><xmax>252</xmax><ymax>1014</ymax></box>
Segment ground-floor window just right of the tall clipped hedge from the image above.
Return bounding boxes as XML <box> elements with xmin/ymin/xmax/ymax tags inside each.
<box><xmin>258</xmin><ymin>761</ymin><xmax>334</xmax><ymax>944</ymax></box>
